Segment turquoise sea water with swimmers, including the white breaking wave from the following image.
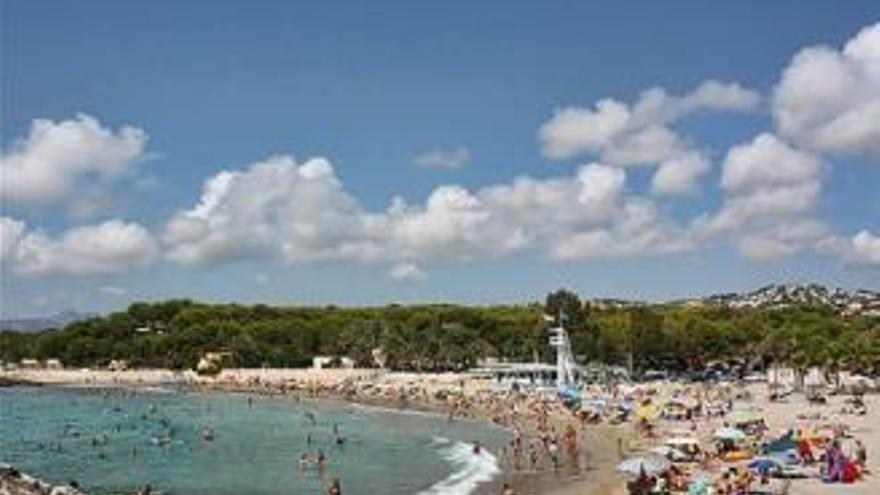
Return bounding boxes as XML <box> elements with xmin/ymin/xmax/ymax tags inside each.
<box><xmin>0</xmin><ymin>388</ymin><xmax>507</xmax><ymax>495</ymax></box>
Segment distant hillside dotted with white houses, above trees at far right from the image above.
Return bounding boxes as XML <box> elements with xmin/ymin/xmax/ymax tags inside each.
<box><xmin>683</xmin><ymin>284</ymin><xmax>880</xmax><ymax>316</ymax></box>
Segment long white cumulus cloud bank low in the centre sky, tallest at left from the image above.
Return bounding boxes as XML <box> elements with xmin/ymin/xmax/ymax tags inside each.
<box><xmin>162</xmin><ymin>156</ymin><xmax>680</xmax><ymax>274</ymax></box>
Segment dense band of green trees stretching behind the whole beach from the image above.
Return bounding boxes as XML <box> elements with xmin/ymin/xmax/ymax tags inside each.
<box><xmin>0</xmin><ymin>290</ymin><xmax>880</xmax><ymax>372</ymax></box>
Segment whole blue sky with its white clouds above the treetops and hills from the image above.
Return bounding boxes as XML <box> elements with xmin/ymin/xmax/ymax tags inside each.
<box><xmin>0</xmin><ymin>0</ymin><xmax>880</xmax><ymax>315</ymax></box>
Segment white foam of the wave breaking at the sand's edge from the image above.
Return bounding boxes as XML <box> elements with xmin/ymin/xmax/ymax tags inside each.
<box><xmin>419</xmin><ymin>437</ymin><xmax>501</xmax><ymax>495</ymax></box>
